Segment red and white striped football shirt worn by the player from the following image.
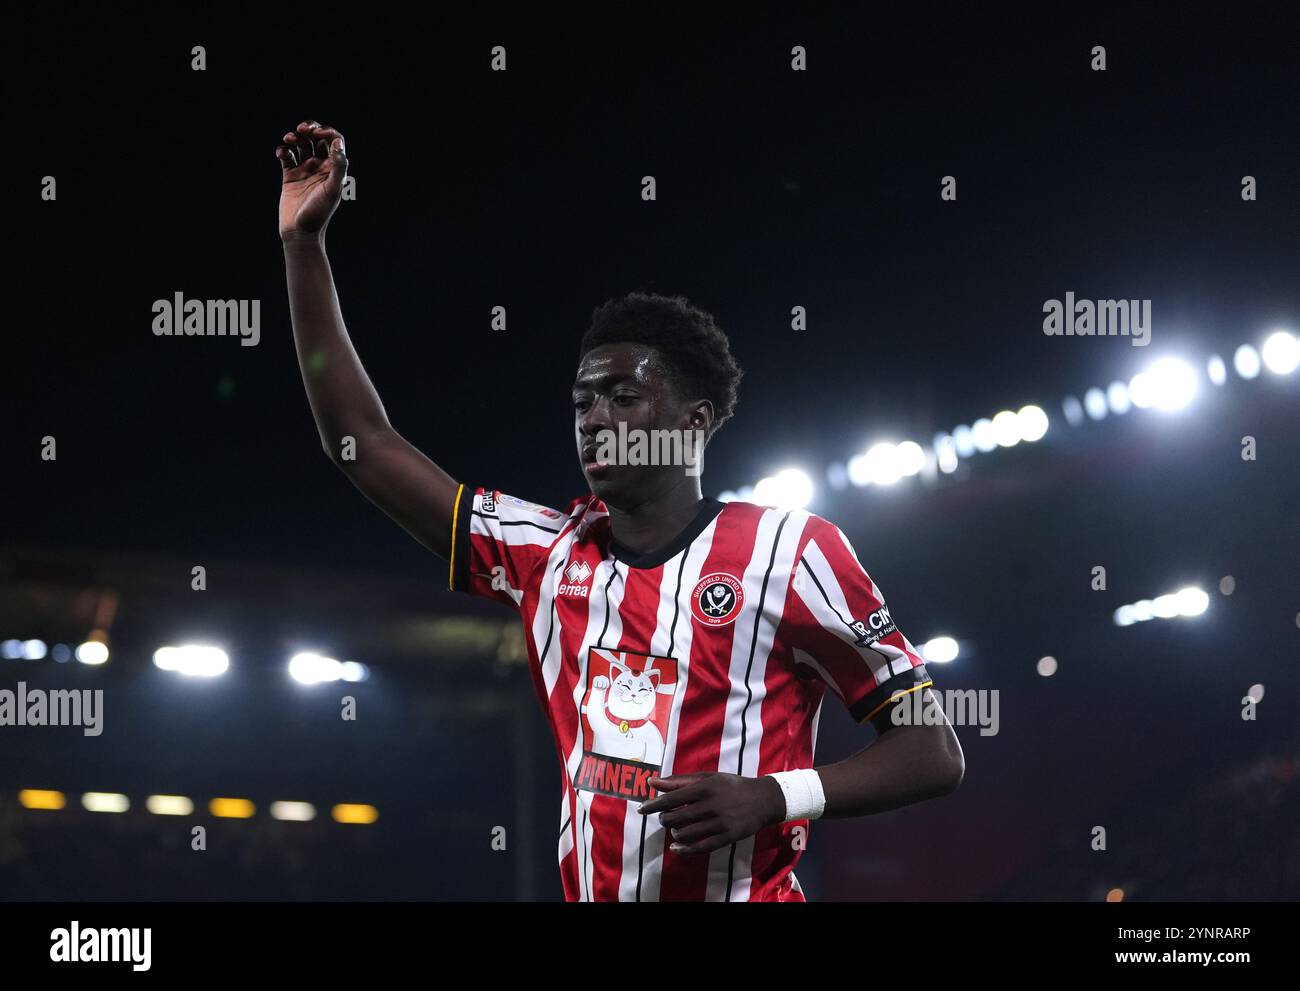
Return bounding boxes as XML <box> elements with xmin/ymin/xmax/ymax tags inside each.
<box><xmin>450</xmin><ymin>486</ymin><xmax>931</xmax><ymax>901</ymax></box>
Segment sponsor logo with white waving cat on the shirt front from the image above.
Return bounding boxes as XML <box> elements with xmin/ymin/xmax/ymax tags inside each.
<box><xmin>573</xmin><ymin>646</ymin><xmax>677</xmax><ymax>802</ymax></box>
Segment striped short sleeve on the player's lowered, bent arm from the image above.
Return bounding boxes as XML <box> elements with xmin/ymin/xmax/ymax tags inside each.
<box><xmin>787</xmin><ymin>516</ymin><xmax>932</xmax><ymax>732</ymax></box>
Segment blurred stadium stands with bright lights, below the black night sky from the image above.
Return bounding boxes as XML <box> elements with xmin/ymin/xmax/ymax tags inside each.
<box><xmin>0</xmin><ymin>330</ymin><xmax>1300</xmax><ymax>900</ymax></box>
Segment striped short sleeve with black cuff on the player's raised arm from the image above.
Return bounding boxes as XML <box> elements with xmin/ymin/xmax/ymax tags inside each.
<box><xmin>447</xmin><ymin>485</ymin><xmax>568</xmax><ymax>607</ymax></box>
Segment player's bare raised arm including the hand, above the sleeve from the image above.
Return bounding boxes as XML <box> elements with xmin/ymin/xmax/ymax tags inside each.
<box><xmin>276</xmin><ymin>121</ymin><xmax>459</xmax><ymax>558</ymax></box>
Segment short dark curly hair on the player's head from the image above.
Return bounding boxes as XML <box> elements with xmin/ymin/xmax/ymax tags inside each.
<box><xmin>577</xmin><ymin>291</ymin><xmax>744</xmax><ymax>436</ymax></box>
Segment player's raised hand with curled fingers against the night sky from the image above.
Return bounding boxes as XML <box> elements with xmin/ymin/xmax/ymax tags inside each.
<box><xmin>276</xmin><ymin>121</ymin><xmax>347</xmax><ymax>238</ymax></box>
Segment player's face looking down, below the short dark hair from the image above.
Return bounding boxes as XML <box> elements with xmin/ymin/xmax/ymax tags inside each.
<box><xmin>573</xmin><ymin>345</ymin><xmax>694</xmax><ymax>509</ymax></box>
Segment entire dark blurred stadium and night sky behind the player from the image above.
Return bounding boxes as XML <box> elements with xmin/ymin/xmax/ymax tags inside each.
<box><xmin>0</xmin><ymin>4</ymin><xmax>1300</xmax><ymax>900</ymax></box>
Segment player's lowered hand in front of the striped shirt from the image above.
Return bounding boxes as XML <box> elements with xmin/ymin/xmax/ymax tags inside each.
<box><xmin>640</xmin><ymin>773</ymin><xmax>785</xmax><ymax>853</ymax></box>
